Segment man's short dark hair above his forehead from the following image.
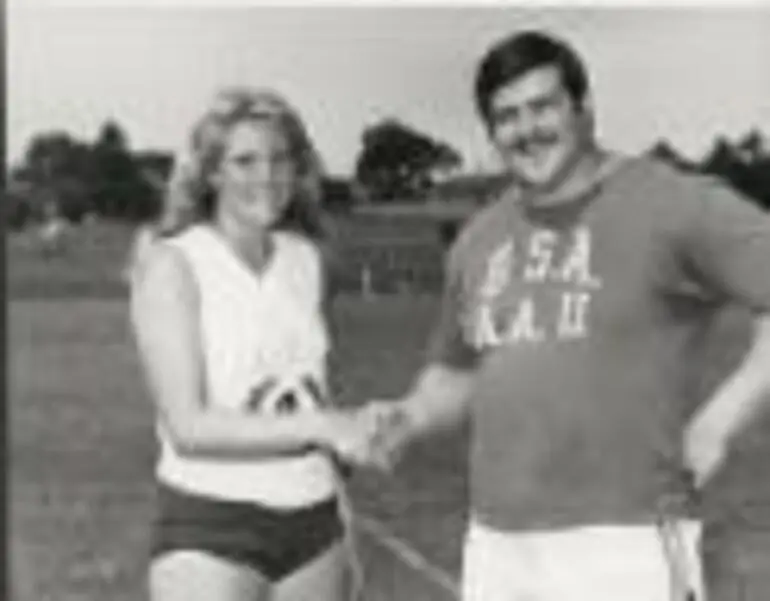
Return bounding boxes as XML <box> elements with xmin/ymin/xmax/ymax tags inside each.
<box><xmin>475</xmin><ymin>31</ymin><xmax>589</xmax><ymax>123</ymax></box>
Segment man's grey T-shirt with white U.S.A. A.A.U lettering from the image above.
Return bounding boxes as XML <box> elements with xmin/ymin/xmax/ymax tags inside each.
<box><xmin>432</xmin><ymin>159</ymin><xmax>770</xmax><ymax>530</ymax></box>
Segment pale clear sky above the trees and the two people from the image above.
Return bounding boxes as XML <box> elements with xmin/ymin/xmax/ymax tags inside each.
<box><xmin>7</xmin><ymin>1</ymin><xmax>770</xmax><ymax>175</ymax></box>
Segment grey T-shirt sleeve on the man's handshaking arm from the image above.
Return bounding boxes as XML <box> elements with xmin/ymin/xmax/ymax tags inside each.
<box><xmin>427</xmin><ymin>240</ymin><xmax>481</xmax><ymax>370</ymax></box>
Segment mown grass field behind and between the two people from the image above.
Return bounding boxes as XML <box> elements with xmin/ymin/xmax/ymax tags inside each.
<box><xmin>8</xmin><ymin>224</ymin><xmax>770</xmax><ymax>601</ymax></box>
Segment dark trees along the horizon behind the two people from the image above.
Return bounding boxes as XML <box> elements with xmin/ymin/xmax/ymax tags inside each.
<box><xmin>4</xmin><ymin>119</ymin><xmax>770</xmax><ymax>227</ymax></box>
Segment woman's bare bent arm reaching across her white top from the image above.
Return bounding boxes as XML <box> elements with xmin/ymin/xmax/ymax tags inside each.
<box><xmin>131</xmin><ymin>242</ymin><xmax>364</xmax><ymax>459</ymax></box>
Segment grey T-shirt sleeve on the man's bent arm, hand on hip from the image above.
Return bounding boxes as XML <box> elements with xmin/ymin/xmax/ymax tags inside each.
<box><xmin>679</xmin><ymin>178</ymin><xmax>770</xmax><ymax>312</ymax></box>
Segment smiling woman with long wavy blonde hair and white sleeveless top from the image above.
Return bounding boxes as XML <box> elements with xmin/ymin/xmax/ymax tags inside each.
<box><xmin>131</xmin><ymin>90</ymin><xmax>375</xmax><ymax>601</ymax></box>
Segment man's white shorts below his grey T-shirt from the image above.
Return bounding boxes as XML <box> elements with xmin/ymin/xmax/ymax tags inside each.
<box><xmin>462</xmin><ymin>520</ymin><xmax>705</xmax><ymax>601</ymax></box>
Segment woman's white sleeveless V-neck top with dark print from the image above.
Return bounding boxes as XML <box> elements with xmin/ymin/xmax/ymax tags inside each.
<box><xmin>157</xmin><ymin>225</ymin><xmax>335</xmax><ymax>508</ymax></box>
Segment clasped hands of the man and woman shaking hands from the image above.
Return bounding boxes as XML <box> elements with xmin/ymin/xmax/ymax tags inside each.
<box><xmin>322</xmin><ymin>401</ymin><xmax>412</xmax><ymax>470</ymax></box>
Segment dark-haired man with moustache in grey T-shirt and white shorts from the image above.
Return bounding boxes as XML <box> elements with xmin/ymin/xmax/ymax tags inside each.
<box><xmin>364</xmin><ymin>32</ymin><xmax>770</xmax><ymax>601</ymax></box>
